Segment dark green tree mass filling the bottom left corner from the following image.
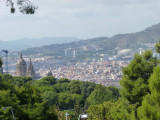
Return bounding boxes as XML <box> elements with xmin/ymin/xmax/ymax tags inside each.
<box><xmin>0</xmin><ymin>74</ymin><xmax>57</xmax><ymax>120</ymax></box>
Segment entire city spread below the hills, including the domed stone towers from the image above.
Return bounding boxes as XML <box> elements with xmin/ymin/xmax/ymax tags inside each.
<box><xmin>0</xmin><ymin>43</ymin><xmax>160</xmax><ymax>86</ymax></box>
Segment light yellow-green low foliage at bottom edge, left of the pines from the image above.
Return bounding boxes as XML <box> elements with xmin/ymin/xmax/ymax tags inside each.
<box><xmin>87</xmin><ymin>99</ymin><xmax>136</xmax><ymax>120</ymax></box>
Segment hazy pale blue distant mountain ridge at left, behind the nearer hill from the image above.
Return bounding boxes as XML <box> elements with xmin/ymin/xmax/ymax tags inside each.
<box><xmin>0</xmin><ymin>37</ymin><xmax>79</xmax><ymax>50</ymax></box>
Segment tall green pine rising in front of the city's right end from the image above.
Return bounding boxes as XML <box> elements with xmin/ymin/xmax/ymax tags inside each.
<box><xmin>120</xmin><ymin>50</ymin><xmax>157</xmax><ymax>105</ymax></box>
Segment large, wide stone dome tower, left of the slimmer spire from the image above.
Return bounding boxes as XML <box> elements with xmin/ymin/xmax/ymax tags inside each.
<box><xmin>16</xmin><ymin>54</ymin><xmax>27</xmax><ymax>77</ymax></box>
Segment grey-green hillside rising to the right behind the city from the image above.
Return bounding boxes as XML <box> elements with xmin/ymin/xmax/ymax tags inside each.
<box><xmin>23</xmin><ymin>23</ymin><xmax>160</xmax><ymax>57</ymax></box>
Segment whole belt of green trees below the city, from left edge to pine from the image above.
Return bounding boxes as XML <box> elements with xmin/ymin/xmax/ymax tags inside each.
<box><xmin>0</xmin><ymin>74</ymin><xmax>119</xmax><ymax>120</ymax></box>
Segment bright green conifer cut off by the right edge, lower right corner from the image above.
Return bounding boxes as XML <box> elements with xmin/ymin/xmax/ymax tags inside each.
<box><xmin>138</xmin><ymin>66</ymin><xmax>160</xmax><ymax>120</ymax></box>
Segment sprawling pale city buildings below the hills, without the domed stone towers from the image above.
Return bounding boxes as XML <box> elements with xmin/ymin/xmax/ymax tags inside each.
<box><xmin>2</xmin><ymin>44</ymin><xmax>159</xmax><ymax>87</ymax></box>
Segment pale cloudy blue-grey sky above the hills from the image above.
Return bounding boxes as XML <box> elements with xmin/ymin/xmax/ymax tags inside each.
<box><xmin>0</xmin><ymin>0</ymin><xmax>160</xmax><ymax>41</ymax></box>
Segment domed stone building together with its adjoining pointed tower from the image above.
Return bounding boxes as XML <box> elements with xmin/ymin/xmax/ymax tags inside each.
<box><xmin>16</xmin><ymin>54</ymin><xmax>35</xmax><ymax>78</ymax></box>
